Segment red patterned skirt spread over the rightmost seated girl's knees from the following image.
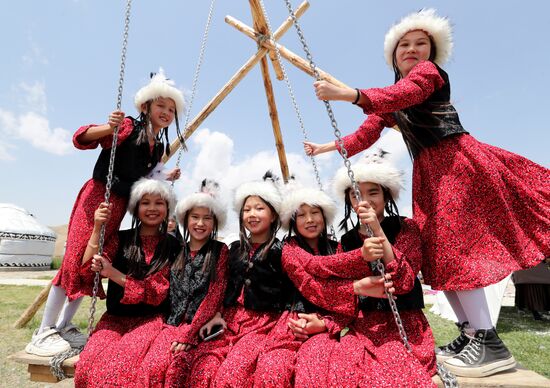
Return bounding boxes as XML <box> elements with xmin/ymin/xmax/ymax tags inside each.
<box><xmin>295</xmin><ymin>318</ymin><xmax>436</xmax><ymax>388</ymax></box>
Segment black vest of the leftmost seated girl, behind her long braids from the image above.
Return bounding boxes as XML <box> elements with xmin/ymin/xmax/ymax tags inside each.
<box><xmin>107</xmin><ymin>229</ymin><xmax>181</xmax><ymax>317</ymax></box>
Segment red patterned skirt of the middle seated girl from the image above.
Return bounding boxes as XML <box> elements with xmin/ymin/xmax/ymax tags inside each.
<box><xmin>183</xmin><ymin>305</ymin><xmax>281</xmax><ymax>387</ymax></box>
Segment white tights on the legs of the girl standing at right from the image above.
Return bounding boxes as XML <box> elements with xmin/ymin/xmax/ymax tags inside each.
<box><xmin>444</xmin><ymin>288</ymin><xmax>493</xmax><ymax>330</ymax></box>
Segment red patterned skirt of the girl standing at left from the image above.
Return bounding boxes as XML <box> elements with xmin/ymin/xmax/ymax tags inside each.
<box><xmin>53</xmin><ymin>179</ymin><xmax>128</xmax><ymax>300</ymax></box>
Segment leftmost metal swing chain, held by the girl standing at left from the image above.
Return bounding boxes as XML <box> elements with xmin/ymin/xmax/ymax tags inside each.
<box><xmin>88</xmin><ymin>0</ymin><xmax>132</xmax><ymax>335</ymax></box>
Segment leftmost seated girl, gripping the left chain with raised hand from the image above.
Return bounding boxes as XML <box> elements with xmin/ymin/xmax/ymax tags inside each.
<box><xmin>75</xmin><ymin>178</ymin><xmax>181</xmax><ymax>387</ymax></box>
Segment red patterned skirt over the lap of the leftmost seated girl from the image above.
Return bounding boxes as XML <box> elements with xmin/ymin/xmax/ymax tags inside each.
<box><xmin>74</xmin><ymin>313</ymin><xmax>163</xmax><ymax>388</ymax></box>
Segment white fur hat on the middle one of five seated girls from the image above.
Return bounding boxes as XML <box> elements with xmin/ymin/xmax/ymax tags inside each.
<box><xmin>233</xmin><ymin>171</ymin><xmax>282</xmax><ymax>214</ymax></box>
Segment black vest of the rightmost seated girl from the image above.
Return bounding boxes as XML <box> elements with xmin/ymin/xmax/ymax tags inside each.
<box><xmin>341</xmin><ymin>217</ymin><xmax>424</xmax><ymax>312</ymax></box>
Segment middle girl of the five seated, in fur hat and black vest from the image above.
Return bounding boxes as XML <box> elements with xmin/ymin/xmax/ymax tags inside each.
<box><xmin>185</xmin><ymin>172</ymin><xmax>290</xmax><ymax>387</ymax></box>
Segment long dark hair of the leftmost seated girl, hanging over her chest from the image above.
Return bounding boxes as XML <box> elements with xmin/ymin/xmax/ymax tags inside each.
<box><xmin>122</xmin><ymin>200</ymin><xmax>170</xmax><ymax>279</ymax></box>
